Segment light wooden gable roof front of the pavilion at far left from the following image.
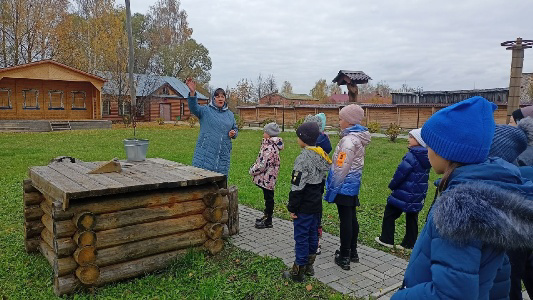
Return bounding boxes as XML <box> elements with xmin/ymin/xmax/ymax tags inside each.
<box><xmin>0</xmin><ymin>59</ymin><xmax>106</xmax><ymax>90</ymax></box>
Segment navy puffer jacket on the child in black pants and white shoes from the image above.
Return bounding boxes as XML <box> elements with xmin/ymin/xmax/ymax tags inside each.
<box><xmin>387</xmin><ymin>146</ymin><xmax>431</xmax><ymax>212</ymax></box>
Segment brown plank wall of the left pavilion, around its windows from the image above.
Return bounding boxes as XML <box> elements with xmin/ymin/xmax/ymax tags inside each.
<box><xmin>0</xmin><ymin>78</ymin><xmax>96</xmax><ymax>120</ymax></box>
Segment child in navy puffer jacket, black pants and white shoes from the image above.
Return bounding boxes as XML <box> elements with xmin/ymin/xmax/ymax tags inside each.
<box><xmin>376</xmin><ymin>128</ymin><xmax>431</xmax><ymax>249</ymax></box>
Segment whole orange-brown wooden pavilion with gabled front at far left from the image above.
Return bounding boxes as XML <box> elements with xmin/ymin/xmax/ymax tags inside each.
<box><xmin>0</xmin><ymin>60</ymin><xmax>105</xmax><ymax>120</ymax></box>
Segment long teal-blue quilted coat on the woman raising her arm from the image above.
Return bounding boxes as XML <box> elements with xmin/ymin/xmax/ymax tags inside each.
<box><xmin>187</xmin><ymin>92</ymin><xmax>238</xmax><ymax>176</ymax></box>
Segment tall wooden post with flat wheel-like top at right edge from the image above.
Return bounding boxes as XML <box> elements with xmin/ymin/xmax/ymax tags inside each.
<box><xmin>501</xmin><ymin>38</ymin><xmax>533</xmax><ymax>124</ymax></box>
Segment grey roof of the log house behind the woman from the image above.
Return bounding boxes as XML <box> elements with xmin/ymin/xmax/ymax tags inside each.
<box><xmin>101</xmin><ymin>72</ymin><xmax>209</xmax><ymax>100</ymax></box>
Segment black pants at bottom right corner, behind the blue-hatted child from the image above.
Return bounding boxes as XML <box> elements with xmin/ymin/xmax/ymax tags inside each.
<box><xmin>507</xmin><ymin>250</ymin><xmax>533</xmax><ymax>300</ymax></box>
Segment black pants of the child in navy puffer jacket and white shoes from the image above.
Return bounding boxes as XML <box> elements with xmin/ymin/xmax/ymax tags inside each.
<box><xmin>379</xmin><ymin>203</ymin><xmax>418</xmax><ymax>249</ymax></box>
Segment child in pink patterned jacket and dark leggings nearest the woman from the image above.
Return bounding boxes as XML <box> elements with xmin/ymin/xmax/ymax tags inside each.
<box><xmin>249</xmin><ymin>122</ymin><xmax>283</xmax><ymax>229</ymax></box>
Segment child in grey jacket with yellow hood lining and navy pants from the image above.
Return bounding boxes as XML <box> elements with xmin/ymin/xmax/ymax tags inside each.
<box><xmin>283</xmin><ymin>122</ymin><xmax>331</xmax><ymax>282</ymax></box>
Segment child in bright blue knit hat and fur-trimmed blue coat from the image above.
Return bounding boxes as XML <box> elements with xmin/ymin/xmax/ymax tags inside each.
<box><xmin>391</xmin><ymin>97</ymin><xmax>533</xmax><ymax>300</ymax></box>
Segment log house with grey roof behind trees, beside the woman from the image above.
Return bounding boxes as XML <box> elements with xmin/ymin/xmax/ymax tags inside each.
<box><xmin>102</xmin><ymin>73</ymin><xmax>209</xmax><ymax>122</ymax></box>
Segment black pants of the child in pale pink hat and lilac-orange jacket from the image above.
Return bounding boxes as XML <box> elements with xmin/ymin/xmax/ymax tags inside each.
<box><xmin>337</xmin><ymin>203</ymin><xmax>359</xmax><ymax>257</ymax></box>
